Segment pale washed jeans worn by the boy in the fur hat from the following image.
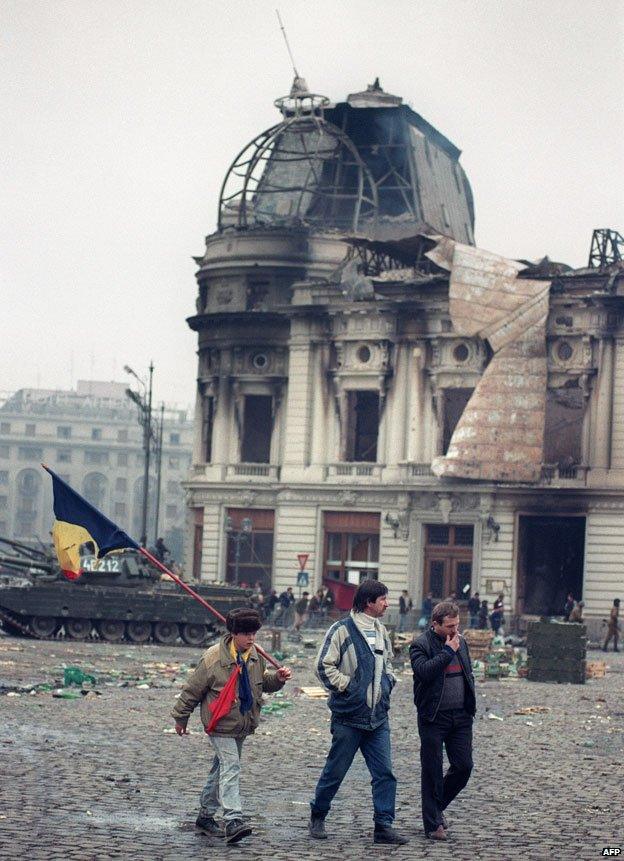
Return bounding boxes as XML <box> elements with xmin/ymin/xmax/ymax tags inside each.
<box><xmin>199</xmin><ymin>735</ymin><xmax>243</xmax><ymax>822</ymax></box>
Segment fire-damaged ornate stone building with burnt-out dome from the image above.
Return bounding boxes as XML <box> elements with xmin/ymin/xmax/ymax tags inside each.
<box><xmin>186</xmin><ymin>78</ymin><xmax>624</xmax><ymax>626</ymax></box>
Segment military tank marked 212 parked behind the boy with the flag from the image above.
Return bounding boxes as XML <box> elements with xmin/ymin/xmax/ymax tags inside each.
<box><xmin>0</xmin><ymin>538</ymin><xmax>251</xmax><ymax>646</ymax></box>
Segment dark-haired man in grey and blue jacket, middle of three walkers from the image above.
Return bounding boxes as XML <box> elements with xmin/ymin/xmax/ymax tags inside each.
<box><xmin>309</xmin><ymin>580</ymin><xmax>407</xmax><ymax>845</ymax></box>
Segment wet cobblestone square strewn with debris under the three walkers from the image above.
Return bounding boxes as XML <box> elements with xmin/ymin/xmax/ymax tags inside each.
<box><xmin>0</xmin><ymin>632</ymin><xmax>624</xmax><ymax>861</ymax></box>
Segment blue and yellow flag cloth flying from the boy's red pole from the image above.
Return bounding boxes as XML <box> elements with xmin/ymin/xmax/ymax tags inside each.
<box><xmin>42</xmin><ymin>464</ymin><xmax>139</xmax><ymax>580</ymax></box>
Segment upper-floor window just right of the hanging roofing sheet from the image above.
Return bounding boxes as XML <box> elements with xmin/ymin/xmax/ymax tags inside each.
<box><xmin>544</xmin><ymin>380</ymin><xmax>585</xmax><ymax>467</ymax></box>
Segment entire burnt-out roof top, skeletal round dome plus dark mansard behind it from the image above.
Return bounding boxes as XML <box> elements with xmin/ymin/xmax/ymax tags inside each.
<box><xmin>219</xmin><ymin>78</ymin><xmax>474</xmax><ymax>245</ymax></box>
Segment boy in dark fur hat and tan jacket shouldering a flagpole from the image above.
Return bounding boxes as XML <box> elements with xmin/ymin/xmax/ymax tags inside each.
<box><xmin>172</xmin><ymin>608</ymin><xmax>292</xmax><ymax>843</ymax></box>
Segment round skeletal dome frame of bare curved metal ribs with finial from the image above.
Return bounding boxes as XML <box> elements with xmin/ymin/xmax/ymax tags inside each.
<box><xmin>219</xmin><ymin>78</ymin><xmax>378</xmax><ymax>232</ymax></box>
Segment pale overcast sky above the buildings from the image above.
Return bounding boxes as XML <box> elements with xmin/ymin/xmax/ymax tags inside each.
<box><xmin>0</xmin><ymin>0</ymin><xmax>624</xmax><ymax>406</ymax></box>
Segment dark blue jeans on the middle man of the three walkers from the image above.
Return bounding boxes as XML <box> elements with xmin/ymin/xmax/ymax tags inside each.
<box><xmin>310</xmin><ymin>720</ymin><xmax>396</xmax><ymax>825</ymax></box>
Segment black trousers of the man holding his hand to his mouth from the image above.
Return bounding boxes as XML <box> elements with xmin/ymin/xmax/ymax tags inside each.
<box><xmin>418</xmin><ymin>709</ymin><xmax>473</xmax><ymax>834</ymax></box>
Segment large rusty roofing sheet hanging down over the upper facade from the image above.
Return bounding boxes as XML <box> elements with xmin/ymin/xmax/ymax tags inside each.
<box><xmin>428</xmin><ymin>240</ymin><xmax>550</xmax><ymax>482</ymax></box>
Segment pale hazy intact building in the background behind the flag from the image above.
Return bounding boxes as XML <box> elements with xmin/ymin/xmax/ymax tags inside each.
<box><xmin>0</xmin><ymin>380</ymin><xmax>193</xmax><ymax>560</ymax></box>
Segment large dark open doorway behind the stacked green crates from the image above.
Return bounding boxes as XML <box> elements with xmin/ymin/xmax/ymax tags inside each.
<box><xmin>518</xmin><ymin>515</ymin><xmax>585</xmax><ymax>616</ymax></box>
